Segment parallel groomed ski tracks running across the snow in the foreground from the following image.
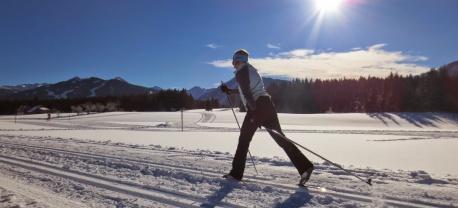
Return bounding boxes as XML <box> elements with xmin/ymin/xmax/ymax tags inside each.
<box><xmin>0</xmin><ymin>139</ymin><xmax>452</xmax><ymax>207</ymax></box>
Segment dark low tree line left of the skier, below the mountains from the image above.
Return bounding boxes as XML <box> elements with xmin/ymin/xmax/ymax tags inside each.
<box><xmin>0</xmin><ymin>89</ymin><xmax>220</xmax><ymax>114</ymax></box>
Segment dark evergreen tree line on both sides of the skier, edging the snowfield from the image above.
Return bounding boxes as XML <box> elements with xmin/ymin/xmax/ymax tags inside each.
<box><xmin>0</xmin><ymin>67</ymin><xmax>458</xmax><ymax>114</ymax></box>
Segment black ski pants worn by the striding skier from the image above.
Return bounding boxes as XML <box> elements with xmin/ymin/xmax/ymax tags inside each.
<box><xmin>229</xmin><ymin>96</ymin><xmax>313</xmax><ymax>180</ymax></box>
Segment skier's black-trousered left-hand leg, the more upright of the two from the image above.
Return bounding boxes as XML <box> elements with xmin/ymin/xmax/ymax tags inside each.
<box><xmin>229</xmin><ymin>115</ymin><xmax>257</xmax><ymax>180</ymax></box>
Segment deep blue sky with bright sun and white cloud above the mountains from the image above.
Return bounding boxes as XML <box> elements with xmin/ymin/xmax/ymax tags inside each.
<box><xmin>0</xmin><ymin>0</ymin><xmax>458</xmax><ymax>89</ymax></box>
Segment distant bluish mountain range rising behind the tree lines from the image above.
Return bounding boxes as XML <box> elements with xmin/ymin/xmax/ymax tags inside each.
<box><xmin>0</xmin><ymin>61</ymin><xmax>458</xmax><ymax>103</ymax></box>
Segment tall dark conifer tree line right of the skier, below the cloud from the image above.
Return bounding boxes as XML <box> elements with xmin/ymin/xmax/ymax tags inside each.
<box><xmin>267</xmin><ymin>67</ymin><xmax>458</xmax><ymax>113</ymax></box>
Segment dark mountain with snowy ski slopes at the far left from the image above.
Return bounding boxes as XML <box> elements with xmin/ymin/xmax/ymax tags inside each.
<box><xmin>1</xmin><ymin>77</ymin><xmax>154</xmax><ymax>99</ymax></box>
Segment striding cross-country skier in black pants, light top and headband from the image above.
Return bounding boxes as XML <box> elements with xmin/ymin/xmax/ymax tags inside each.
<box><xmin>220</xmin><ymin>49</ymin><xmax>314</xmax><ymax>185</ymax></box>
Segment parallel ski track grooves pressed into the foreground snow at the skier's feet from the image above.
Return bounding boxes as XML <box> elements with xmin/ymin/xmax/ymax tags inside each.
<box><xmin>0</xmin><ymin>142</ymin><xmax>452</xmax><ymax>207</ymax></box>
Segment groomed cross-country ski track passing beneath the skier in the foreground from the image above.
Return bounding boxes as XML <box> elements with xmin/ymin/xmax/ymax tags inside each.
<box><xmin>0</xmin><ymin>137</ymin><xmax>447</xmax><ymax>207</ymax></box>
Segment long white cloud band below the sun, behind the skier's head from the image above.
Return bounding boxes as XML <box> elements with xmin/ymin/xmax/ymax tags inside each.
<box><xmin>208</xmin><ymin>44</ymin><xmax>430</xmax><ymax>79</ymax></box>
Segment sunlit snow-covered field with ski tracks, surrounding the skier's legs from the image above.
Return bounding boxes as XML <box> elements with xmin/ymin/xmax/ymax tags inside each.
<box><xmin>0</xmin><ymin>109</ymin><xmax>458</xmax><ymax>207</ymax></box>
